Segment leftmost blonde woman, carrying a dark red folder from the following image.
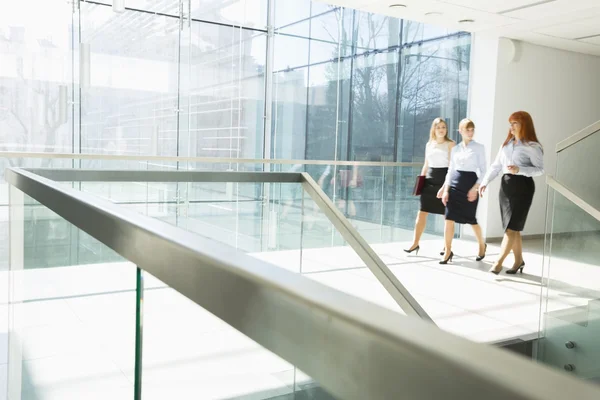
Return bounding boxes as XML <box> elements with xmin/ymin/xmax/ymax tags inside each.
<box><xmin>404</xmin><ymin>118</ymin><xmax>455</xmax><ymax>254</ymax></box>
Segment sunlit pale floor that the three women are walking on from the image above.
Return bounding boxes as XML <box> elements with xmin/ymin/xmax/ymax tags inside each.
<box><xmin>256</xmin><ymin>239</ymin><xmax>600</xmax><ymax>342</ymax></box>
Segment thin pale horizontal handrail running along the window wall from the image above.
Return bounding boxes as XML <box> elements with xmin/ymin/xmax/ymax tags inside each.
<box><xmin>0</xmin><ymin>151</ymin><xmax>423</xmax><ymax>167</ymax></box>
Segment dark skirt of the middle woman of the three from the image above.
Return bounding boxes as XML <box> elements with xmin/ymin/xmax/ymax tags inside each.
<box><xmin>446</xmin><ymin>171</ymin><xmax>479</xmax><ymax>225</ymax></box>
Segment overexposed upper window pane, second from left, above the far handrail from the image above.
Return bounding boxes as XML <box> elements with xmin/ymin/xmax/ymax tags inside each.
<box><xmin>80</xmin><ymin>2</ymin><xmax>179</xmax><ymax>156</ymax></box>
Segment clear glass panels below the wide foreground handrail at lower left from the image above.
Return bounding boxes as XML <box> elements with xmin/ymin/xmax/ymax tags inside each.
<box><xmin>7</xmin><ymin>182</ymin><xmax>340</xmax><ymax>400</ymax></box>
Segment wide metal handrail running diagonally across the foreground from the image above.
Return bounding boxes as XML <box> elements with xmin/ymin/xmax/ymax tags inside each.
<box><xmin>6</xmin><ymin>169</ymin><xmax>600</xmax><ymax>400</ymax></box>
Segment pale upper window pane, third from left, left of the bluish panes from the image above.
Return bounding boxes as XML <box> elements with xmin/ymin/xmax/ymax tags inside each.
<box><xmin>179</xmin><ymin>21</ymin><xmax>266</xmax><ymax>158</ymax></box>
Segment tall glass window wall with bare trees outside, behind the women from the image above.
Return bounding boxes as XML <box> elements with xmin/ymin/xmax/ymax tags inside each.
<box><xmin>0</xmin><ymin>0</ymin><xmax>470</xmax><ymax>232</ymax></box>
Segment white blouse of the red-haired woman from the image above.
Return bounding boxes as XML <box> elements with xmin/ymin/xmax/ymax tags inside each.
<box><xmin>481</xmin><ymin>139</ymin><xmax>544</xmax><ymax>186</ymax></box>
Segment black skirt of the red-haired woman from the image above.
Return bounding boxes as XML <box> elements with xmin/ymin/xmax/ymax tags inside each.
<box><xmin>499</xmin><ymin>174</ymin><xmax>535</xmax><ymax>232</ymax></box>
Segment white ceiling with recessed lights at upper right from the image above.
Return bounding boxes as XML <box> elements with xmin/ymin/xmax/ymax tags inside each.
<box><xmin>324</xmin><ymin>0</ymin><xmax>600</xmax><ymax>56</ymax></box>
